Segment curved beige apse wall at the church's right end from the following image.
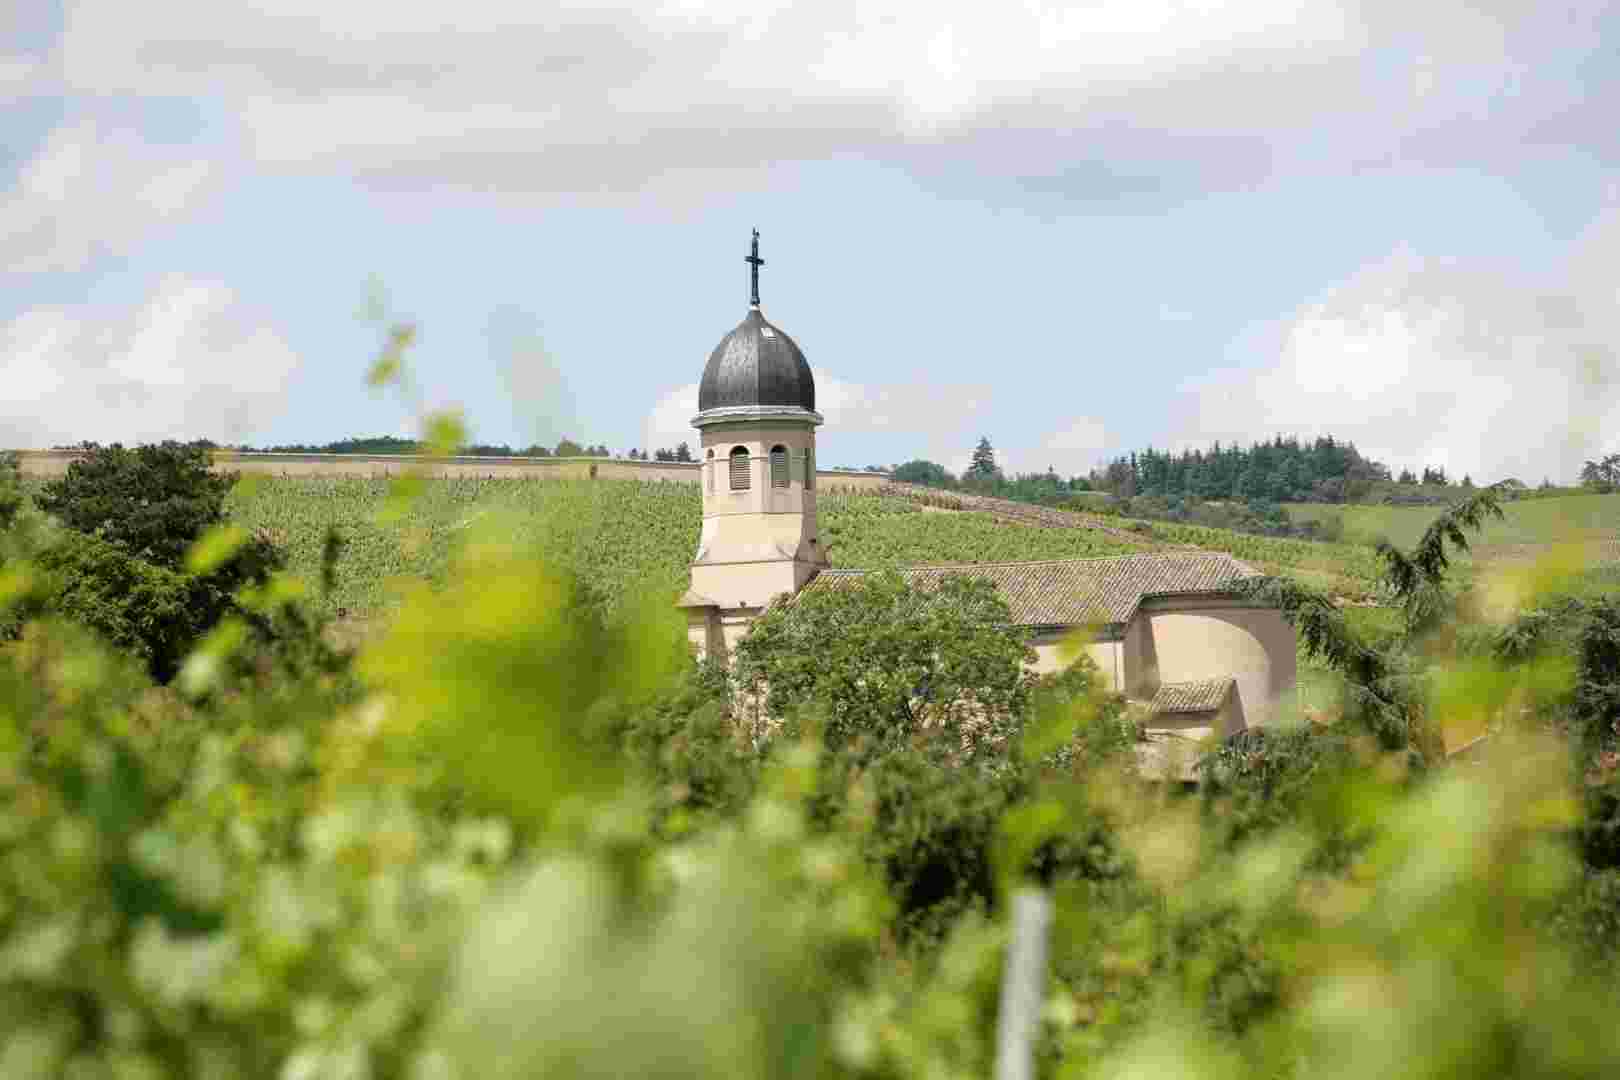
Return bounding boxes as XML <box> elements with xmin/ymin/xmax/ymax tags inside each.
<box><xmin>1144</xmin><ymin>597</ymin><xmax>1298</xmax><ymax>727</ymax></box>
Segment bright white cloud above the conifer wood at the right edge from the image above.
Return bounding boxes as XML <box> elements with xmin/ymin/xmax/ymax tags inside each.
<box><xmin>1181</xmin><ymin>215</ymin><xmax>1620</xmax><ymax>483</ymax></box>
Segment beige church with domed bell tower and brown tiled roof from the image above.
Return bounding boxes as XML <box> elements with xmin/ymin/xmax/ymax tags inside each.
<box><xmin>679</xmin><ymin>232</ymin><xmax>1296</xmax><ymax>772</ymax></box>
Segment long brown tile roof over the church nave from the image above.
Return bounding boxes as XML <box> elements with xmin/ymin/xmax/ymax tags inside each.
<box><xmin>805</xmin><ymin>551</ymin><xmax>1259</xmax><ymax>627</ymax></box>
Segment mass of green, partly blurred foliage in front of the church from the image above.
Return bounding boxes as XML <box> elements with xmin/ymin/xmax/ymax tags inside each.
<box><xmin>9</xmin><ymin>427</ymin><xmax>1620</xmax><ymax>1080</ymax></box>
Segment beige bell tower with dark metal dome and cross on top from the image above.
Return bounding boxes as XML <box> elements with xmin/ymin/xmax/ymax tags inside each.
<box><xmin>680</xmin><ymin>230</ymin><xmax>828</xmax><ymax>656</ymax></box>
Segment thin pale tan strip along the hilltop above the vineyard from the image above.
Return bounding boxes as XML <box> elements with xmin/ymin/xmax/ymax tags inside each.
<box><xmin>16</xmin><ymin>450</ymin><xmax>888</xmax><ymax>491</ymax></box>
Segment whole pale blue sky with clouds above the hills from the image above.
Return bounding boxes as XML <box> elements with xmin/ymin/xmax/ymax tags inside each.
<box><xmin>0</xmin><ymin>0</ymin><xmax>1620</xmax><ymax>483</ymax></box>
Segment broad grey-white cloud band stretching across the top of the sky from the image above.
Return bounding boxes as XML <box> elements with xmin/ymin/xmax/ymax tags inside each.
<box><xmin>58</xmin><ymin>0</ymin><xmax>1607</xmax><ymax>194</ymax></box>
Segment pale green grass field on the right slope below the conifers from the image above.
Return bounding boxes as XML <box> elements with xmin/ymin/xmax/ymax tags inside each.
<box><xmin>1288</xmin><ymin>494</ymin><xmax>1620</xmax><ymax>549</ymax></box>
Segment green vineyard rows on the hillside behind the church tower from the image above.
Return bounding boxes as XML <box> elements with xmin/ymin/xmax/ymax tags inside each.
<box><xmin>232</xmin><ymin>478</ymin><xmax>1406</xmax><ymax>614</ymax></box>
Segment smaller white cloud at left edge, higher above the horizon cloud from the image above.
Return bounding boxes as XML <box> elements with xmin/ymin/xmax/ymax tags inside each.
<box><xmin>0</xmin><ymin>123</ymin><xmax>215</xmax><ymax>274</ymax></box>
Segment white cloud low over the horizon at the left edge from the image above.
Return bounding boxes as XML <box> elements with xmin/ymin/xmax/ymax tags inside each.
<box><xmin>0</xmin><ymin>275</ymin><xmax>298</xmax><ymax>449</ymax></box>
